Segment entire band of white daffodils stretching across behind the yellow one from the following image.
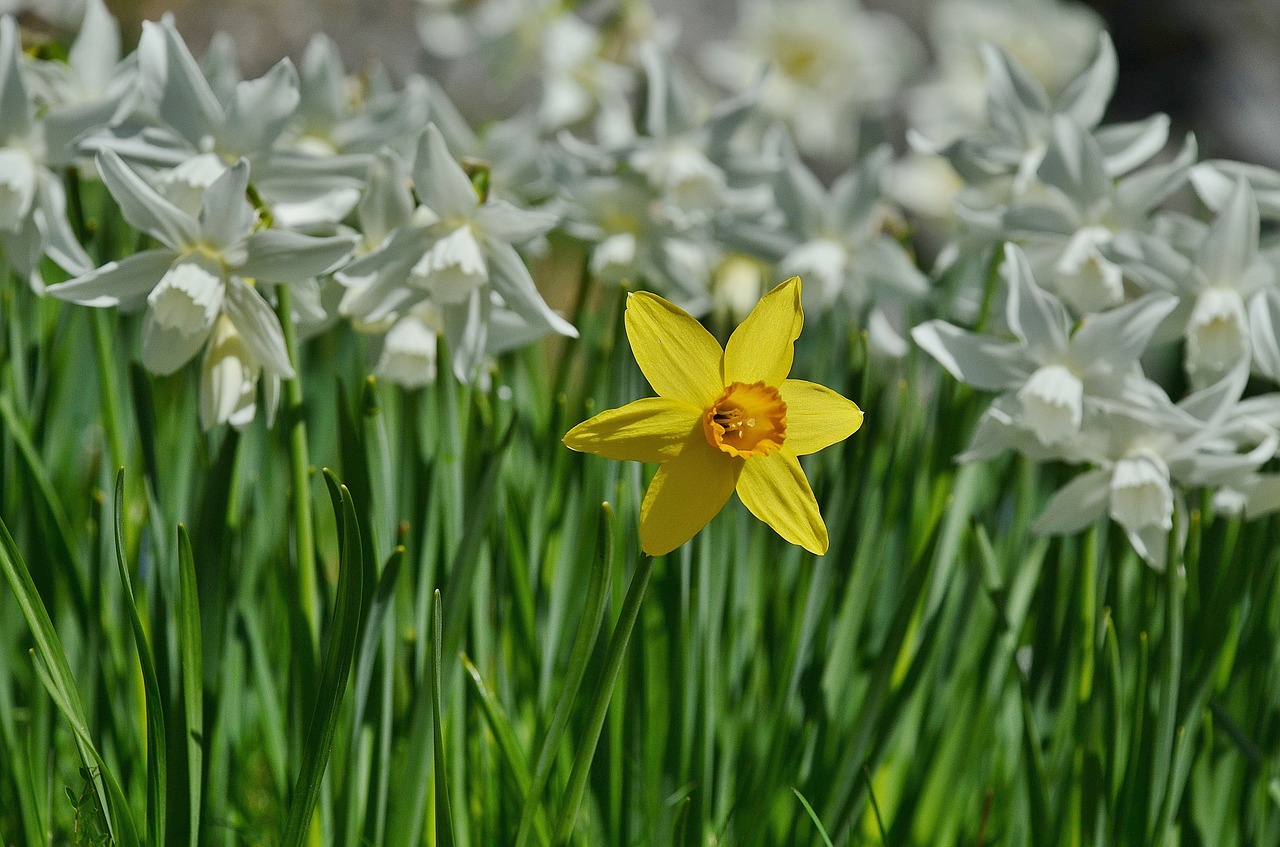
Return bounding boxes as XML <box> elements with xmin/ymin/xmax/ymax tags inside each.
<box><xmin>0</xmin><ymin>0</ymin><xmax>1280</xmax><ymax>567</ymax></box>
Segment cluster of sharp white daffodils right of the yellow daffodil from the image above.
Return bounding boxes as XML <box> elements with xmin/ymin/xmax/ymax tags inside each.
<box><xmin>913</xmin><ymin>36</ymin><xmax>1280</xmax><ymax>567</ymax></box>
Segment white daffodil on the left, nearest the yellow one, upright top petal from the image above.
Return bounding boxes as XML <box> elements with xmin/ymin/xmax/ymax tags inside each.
<box><xmin>338</xmin><ymin>124</ymin><xmax>577</xmax><ymax>381</ymax></box>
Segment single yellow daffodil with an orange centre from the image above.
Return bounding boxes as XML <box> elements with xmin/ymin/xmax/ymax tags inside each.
<box><xmin>564</xmin><ymin>278</ymin><xmax>863</xmax><ymax>555</ymax></box>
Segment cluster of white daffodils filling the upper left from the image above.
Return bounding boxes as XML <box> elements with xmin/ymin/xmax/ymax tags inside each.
<box><xmin>0</xmin><ymin>0</ymin><xmax>576</xmax><ymax>427</ymax></box>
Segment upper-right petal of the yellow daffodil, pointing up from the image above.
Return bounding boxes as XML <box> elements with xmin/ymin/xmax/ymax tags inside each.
<box><xmin>724</xmin><ymin>276</ymin><xmax>804</xmax><ymax>385</ymax></box>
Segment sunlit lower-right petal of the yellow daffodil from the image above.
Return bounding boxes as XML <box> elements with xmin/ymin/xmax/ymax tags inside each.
<box><xmin>737</xmin><ymin>445</ymin><xmax>828</xmax><ymax>555</ymax></box>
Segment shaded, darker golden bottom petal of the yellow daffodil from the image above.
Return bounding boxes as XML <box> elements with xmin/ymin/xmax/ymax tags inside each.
<box><xmin>640</xmin><ymin>429</ymin><xmax>745</xmax><ymax>555</ymax></box>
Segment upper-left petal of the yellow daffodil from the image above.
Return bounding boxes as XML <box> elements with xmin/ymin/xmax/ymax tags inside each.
<box><xmin>626</xmin><ymin>292</ymin><xmax>724</xmax><ymax>408</ymax></box>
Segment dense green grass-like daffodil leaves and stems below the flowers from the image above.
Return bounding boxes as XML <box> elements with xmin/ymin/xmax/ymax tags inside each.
<box><xmin>0</xmin><ymin>200</ymin><xmax>1280</xmax><ymax>847</ymax></box>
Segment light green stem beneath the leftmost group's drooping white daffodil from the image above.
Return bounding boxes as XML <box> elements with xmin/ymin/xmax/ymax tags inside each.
<box><xmin>275</xmin><ymin>285</ymin><xmax>320</xmax><ymax>647</ymax></box>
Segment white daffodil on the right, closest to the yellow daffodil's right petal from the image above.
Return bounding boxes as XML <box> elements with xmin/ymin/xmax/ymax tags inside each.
<box><xmin>911</xmin><ymin>244</ymin><xmax>1178</xmax><ymax>450</ymax></box>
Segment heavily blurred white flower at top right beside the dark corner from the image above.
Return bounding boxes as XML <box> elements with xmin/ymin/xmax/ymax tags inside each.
<box><xmin>908</xmin><ymin>0</ymin><xmax>1102</xmax><ymax>143</ymax></box>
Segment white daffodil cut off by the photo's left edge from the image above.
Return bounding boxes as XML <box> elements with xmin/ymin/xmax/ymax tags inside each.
<box><xmin>0</xmin><ymin>15</ymin><xmax>93</xmax><ymax>292</ymax></box>
